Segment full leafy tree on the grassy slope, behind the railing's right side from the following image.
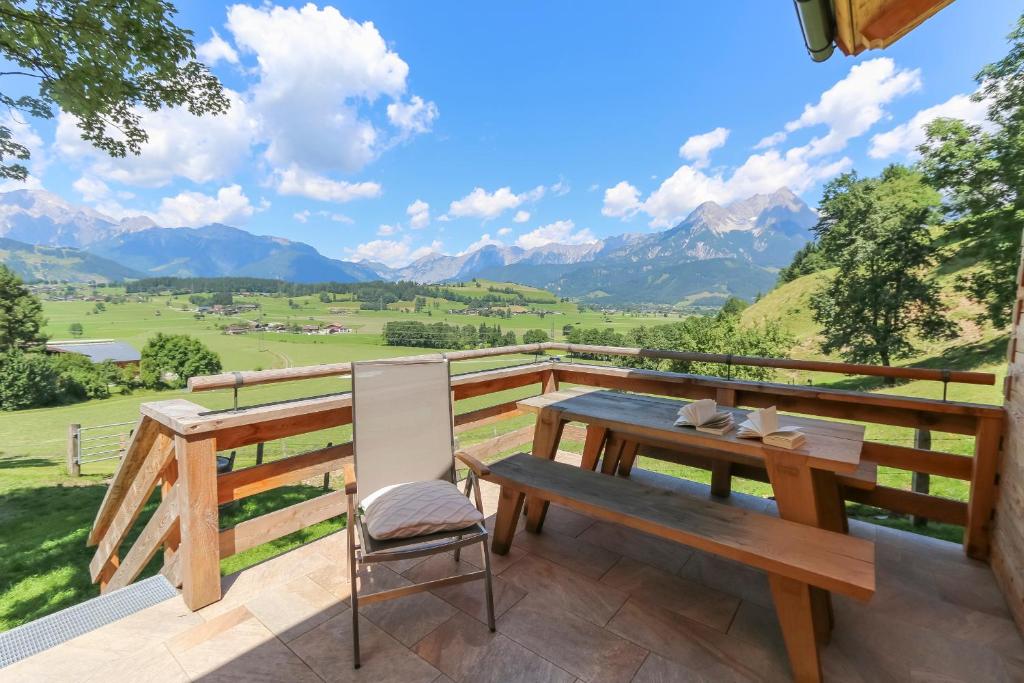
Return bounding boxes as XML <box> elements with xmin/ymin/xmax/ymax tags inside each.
<box><xmin>811</xmin><ymin>165</ymin><xmax>955</xmax><ymax>366</ymax></box>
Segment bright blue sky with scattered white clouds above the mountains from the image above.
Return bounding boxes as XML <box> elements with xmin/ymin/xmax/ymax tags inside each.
<box><xmin>4</xmin><ymin>0</ymin><xmax>1021</xmax><ymax>265</ymax></box>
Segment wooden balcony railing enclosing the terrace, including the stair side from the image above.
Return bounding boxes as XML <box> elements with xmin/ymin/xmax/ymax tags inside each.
<box><xmin>89</xmin><ymin>344</ymin><xmax>1005</xmax><ymax>609</ymax></box>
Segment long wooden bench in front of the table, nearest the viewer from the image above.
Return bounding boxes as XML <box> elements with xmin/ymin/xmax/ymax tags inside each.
<box><xmin>483</xmin><ymin>453</ymin><xmax>874</xmax><ymax>681</ymax></box>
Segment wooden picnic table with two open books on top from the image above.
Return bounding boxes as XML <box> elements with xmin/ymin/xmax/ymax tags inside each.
<box><xmin>518</xmin><ymin>387</ymin><xmax>874</xmax><ymax>531</ymax></box>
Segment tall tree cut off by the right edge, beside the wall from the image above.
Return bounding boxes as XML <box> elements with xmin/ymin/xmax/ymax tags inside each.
<box><xmin>918</xmin><ymin>15</ymin><xmax>1024</xmax><ymax>326</ymax></box>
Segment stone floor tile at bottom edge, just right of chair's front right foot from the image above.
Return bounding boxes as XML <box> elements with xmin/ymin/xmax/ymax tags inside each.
<box><xmin>498</xmin><ymin>594</ymin><xmax>647</xmax><ymax>683</ymax></box>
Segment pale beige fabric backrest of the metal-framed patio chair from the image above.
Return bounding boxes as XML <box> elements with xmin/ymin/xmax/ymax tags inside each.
<box><xmin>352</xmin><ymin>356</ymin><xmax>455</xmax><ymax>503</ymax></box>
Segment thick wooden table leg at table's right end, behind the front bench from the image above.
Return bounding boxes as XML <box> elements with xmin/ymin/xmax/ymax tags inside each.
<box><xmin>765</xmin><ymin>453</ymin><xmax>843</xmax><ymax>644</ymax></box>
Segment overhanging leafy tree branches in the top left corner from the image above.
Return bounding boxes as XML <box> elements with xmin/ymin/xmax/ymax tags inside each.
<box><xmin>0</xmin><ymin>0</ymin><xmax>229</xmax><ymax>180</ymax></box>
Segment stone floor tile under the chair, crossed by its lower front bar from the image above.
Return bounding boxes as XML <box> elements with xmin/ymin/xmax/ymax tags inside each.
<box><xmin>359</xmin><ymin>564</ymin><xmax>455</xmax><ymax>646</ymax></box>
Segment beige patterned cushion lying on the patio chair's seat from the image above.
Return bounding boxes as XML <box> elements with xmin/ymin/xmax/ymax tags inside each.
<box><xmin>362</xmin><ymin>479</ymin><xmax>483</xmax><ymax>541</ymax></box>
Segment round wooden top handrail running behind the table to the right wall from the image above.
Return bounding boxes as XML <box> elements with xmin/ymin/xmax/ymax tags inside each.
<box><xmin>545</xmin><ymin>342</ymin><xmax>995</xmax><ymax>385</ymax></box>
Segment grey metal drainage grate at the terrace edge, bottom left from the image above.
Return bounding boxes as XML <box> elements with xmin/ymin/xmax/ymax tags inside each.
<box><xmin>0</xmin><ymin>574</ymin><xmax>178</xmax><ymax>669</ymax></box>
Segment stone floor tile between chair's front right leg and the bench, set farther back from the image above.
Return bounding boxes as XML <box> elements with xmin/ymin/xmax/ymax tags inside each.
<box><xmin>502</xmin><ymin>555</ymin><xmax>627</xmax><ymax>626</ymax></box>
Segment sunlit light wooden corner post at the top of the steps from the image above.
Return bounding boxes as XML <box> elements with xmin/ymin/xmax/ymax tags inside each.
<box><xmin>174</xmin><ymin>434</ymin><xmax>220</xmax><ymax>611</ymax></box>
